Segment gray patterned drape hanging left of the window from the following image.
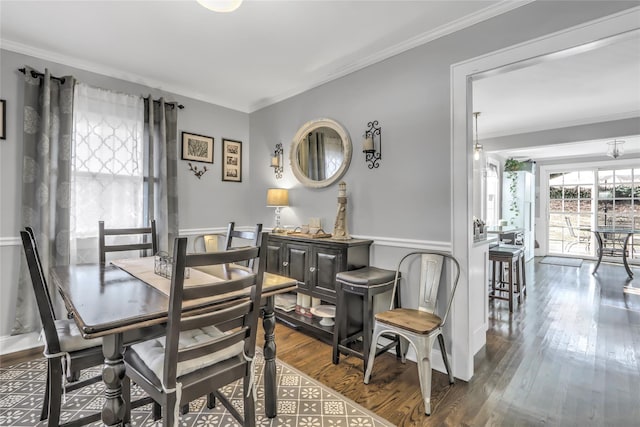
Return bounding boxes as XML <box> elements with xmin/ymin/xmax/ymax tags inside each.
<box><xmin>12</xmin><ymin>67</ymin><xmax>75</xmax><ymax>334</ymax></box>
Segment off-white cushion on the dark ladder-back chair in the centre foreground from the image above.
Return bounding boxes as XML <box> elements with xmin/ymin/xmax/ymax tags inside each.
<box><xmin>131</xmin><ymin>326</ymin><xmax>244</xmax><ymax>380</ymax></box>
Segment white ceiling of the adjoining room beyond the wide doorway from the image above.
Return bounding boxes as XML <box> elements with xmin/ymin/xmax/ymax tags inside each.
<box><xmin>473</xmin><ymin>30</ymin><xmax>640</xmax><ymax>160</ymax></box>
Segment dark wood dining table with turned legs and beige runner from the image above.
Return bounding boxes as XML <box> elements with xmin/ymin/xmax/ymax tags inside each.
<box><xmin>51</xmin><ymin>257</ymin><xmax>297</xmax><ymax>426</ymax></box>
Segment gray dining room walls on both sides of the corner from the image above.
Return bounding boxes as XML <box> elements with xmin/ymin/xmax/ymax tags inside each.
<box><xmin>0</xmin><ymin>1</ymin><xmax>638</xmax><ymax>342</ymax></box>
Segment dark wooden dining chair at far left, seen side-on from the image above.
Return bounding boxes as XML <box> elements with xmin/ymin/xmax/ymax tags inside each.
<box><xmin>20</xmin><ymin>227</ymin><xmax>104</xmax><ymax>426</ymax></box>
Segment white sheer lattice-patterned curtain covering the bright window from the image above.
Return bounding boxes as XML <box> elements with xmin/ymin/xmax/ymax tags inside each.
<box><xmin>70</xmin><ymin>83</ymin><xmax>147</xmax><ymax>263</ymax></box>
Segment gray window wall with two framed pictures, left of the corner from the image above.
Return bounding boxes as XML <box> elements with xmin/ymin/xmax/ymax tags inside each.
<box><xmin>0</xmin><ymin>50</ymin><xmax>255</xmax><ymax>336</ymax></box>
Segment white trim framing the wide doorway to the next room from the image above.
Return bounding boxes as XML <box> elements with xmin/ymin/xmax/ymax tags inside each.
<box><xmin>450</xmin><ymin>7</ymin><xmax>640</xmax><ymax>380</ymax></box>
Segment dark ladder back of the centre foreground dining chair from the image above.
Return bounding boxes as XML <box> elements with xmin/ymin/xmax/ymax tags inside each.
<box><xmin>162</xmin><ymin>234</ymin><xmax>266</xmax><ymax>388</ymax></box>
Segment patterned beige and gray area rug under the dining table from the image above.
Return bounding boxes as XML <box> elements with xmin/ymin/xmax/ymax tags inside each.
<box><xmin>0</xmin><ymin>353</ymin><xmax>392</xmax><ymax>427</ymax></box>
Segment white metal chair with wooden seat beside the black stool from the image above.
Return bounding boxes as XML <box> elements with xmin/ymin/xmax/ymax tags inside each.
<box><xmin>364</xmin><ymin>251</ymin><xmax>460</xmax><ymax>415</ymax></box>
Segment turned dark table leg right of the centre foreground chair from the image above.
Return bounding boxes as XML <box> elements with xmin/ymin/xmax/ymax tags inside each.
<box><xmin>262</xmin><ymin>295</ymin><xmax>278</xmax><ymax>418</ymax></box>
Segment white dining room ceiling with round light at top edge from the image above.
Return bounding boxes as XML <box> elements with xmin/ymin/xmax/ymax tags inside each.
<box><xmin>0</xmin><ymin>0</ymin><xmax>512</xmax><ymax>112</ymax></box>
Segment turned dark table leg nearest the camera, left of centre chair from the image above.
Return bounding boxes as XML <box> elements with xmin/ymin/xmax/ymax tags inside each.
<box><xmin>102</xmin><ymin>334</ymin><xmax>126</xmax><ymax>426</ymax></box>
